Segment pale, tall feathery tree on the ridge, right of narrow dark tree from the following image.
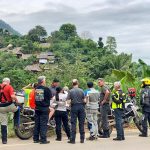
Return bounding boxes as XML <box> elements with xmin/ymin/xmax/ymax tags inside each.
<box><xmin>106</xmin><ymin>36</ymin><xmax>117</xmax><ymax>54</ymax></box>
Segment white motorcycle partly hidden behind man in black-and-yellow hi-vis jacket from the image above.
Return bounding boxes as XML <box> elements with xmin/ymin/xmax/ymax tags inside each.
<box><xmin>98</xmin><ymin>98</ymin><xmax>143</xmax><ymax>135</ymax></box>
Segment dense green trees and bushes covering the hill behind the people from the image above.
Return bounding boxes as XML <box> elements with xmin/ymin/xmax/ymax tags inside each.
<box><xmin>0</xmin><ymin>24</ymin><xmax>150</xmax><ymax>96</ymax></box>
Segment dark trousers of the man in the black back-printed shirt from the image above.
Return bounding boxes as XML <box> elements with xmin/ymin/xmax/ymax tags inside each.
<box><xmin>33</xmin><ymin>110</ymin><xmax>49</xmax><ymax>142</ymax></box>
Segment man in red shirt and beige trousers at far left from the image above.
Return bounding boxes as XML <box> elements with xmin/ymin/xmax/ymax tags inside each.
<box><xmin>0</xmin><ymin>78</ymin><xmax>18</xmax><ymax>144</ymax></box>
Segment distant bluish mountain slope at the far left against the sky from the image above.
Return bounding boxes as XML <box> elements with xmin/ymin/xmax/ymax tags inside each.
<box><xmin>0</xmin><ymin>20</ymin><xmax>21</xmax><ymax>36</ymax></box>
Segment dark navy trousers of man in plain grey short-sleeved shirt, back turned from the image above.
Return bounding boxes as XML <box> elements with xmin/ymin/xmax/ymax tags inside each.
<box><xmin>71</xmin><ymin>104</ymin><xmax>85</xmax><ymax>141</ymax></box>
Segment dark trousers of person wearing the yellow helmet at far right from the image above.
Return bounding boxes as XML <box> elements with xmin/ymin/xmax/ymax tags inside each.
<box><xmin>142</xmin><ymin>111</ymin><xmax>150</xmax><ymax>135</ymax></box>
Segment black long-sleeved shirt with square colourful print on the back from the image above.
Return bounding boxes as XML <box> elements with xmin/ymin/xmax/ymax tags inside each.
<box><xmin>35</xmin><ymin>85</ymin><xmax>52</xmax><ymax>111</ymax></box>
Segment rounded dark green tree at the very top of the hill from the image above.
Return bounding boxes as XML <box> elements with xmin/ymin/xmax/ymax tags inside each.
<box><xmin>59</xmin><ymin>23</ymin><xmax>77</xmax><ymax>40</ymax></box>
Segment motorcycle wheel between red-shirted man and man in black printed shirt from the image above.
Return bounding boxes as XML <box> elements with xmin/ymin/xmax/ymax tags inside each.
<box><xmin>15</xmin><ymin>116</ymin><xmax>33</xmax><ymax>140</ymax></box>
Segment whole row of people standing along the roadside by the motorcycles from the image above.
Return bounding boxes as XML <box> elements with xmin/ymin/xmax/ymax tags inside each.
<box><xmin>0</xmin><ymin>76</ymin><xmax>150</xmax><ymax>144</ymax></box>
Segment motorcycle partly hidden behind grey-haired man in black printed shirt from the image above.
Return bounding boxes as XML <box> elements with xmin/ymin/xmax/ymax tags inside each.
<box><xmin>14</xmin><ymin>94</ymin><xmax>71</xmax><ymax>140</ymax></box>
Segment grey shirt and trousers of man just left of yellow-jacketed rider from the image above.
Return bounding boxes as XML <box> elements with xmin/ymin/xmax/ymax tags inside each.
<box><xmin>100</xmin><ymin>85</ymin><xmax>110</xmax><ymax>138</ymax></box>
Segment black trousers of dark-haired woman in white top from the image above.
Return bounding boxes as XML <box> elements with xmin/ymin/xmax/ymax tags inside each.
<box><xmin>55</xmin><ymin>110</ymin><xmax>70</xmax><ymax>139</ymax></box>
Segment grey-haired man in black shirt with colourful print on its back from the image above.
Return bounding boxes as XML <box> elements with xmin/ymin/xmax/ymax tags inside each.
<box><xmin>33</xmin><ymin>76</ymin><xmax>52</xmax><ymax>144</ymax></box>
